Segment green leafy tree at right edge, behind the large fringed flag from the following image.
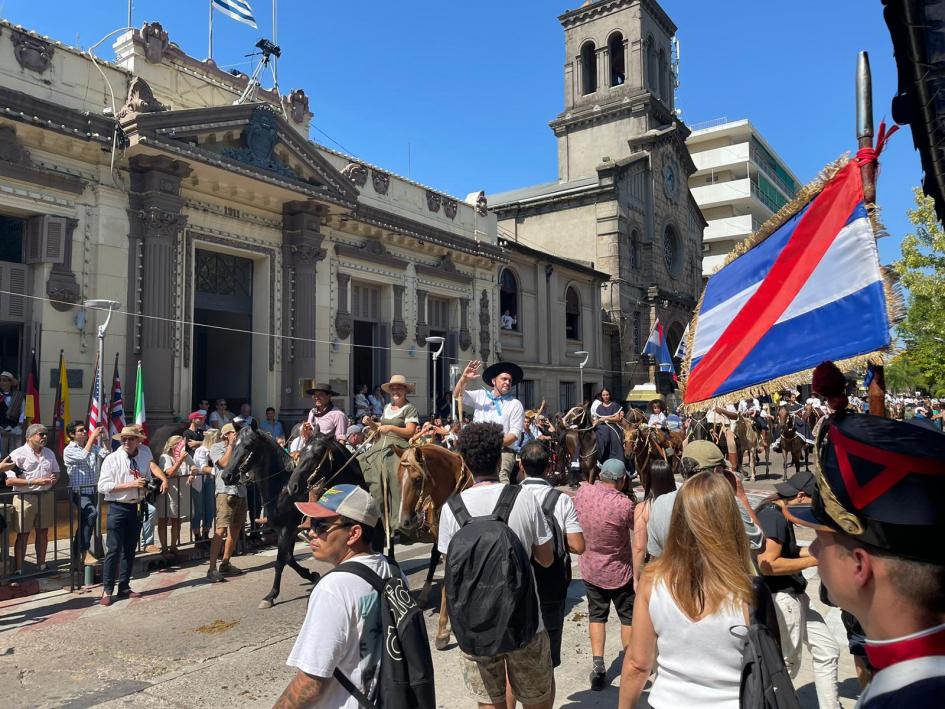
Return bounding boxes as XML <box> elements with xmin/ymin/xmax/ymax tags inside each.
<box><xmin>895</xmin><ymin>188</ymin><xmax>945</xmax><ymax>395</ymax></box>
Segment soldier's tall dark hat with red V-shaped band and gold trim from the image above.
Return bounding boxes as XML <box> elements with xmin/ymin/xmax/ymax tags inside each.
<box><xmin>787</xmin><ymin>411</ymin><xmax>945</xmax><ymax>564</ymax></box>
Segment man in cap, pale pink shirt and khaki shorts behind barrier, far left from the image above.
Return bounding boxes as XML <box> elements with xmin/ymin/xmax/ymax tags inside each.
<box><xmin>7</xmin><ymin>423</ymin><xmax>59</xmax><ymax>576</ymax></box>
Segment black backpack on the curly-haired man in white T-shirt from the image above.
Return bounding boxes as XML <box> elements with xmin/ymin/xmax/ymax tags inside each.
<box><xmin>445</xmin><ymin>485</ymin><xmax>539</xmax><ymax>657</ymax></box>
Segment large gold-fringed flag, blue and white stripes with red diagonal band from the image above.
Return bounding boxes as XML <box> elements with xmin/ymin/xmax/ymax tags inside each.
<box><xmin>683</xmin><ymin>157</ymin><xmax>895</xmax><ymax>408</ymax></box>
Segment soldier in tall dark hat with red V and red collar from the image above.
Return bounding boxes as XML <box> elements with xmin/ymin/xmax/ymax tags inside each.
<box><xmin>787</xmin><ymin>365</ymin><xmax>945</xmax><ymax>709</ymax></box>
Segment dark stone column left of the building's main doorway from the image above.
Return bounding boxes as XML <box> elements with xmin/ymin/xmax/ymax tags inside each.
<box><xmin>127</xmin><ymin>155</ymin><xmax>191</xmax><ymax>430</ymax></box>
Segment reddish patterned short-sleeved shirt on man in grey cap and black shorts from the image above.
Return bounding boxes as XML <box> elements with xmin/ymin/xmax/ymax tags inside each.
<box><xmin>574</xmin><ymin>482</ymin><xmax>633</xmax><ymax>588</ymax></box>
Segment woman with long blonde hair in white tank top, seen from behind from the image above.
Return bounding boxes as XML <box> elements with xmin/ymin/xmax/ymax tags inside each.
<box><xmin>619</xmin><ymin>473</ymin><xmax>752</xmax><ymax>709</ymax></box>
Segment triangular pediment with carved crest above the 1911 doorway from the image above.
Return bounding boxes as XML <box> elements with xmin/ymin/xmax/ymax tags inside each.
<box><xmin>118</xmin><ymin>97</ymin><xmax>358</xmax><ymax>208</ymax></box>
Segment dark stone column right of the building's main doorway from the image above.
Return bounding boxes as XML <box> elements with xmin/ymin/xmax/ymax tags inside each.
<box><xmin>279</xmin><ymin>202</ymin><xmax>325</xmax><ymax>421</ymax></box>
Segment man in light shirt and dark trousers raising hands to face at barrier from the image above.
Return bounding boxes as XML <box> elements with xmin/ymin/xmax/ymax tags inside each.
<box><xmin>62</xmin><ymin>421</ymin><xmax>109</xmax><ymax>566</ymax></box>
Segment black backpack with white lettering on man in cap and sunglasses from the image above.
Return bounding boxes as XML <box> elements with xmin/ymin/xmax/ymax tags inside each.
<box><xmin>322</xmin><ymin>561</ymin><xmax>436</xmax><ymax>709</ymax></box>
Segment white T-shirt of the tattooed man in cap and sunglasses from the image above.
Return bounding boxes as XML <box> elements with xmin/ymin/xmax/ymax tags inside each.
<box><xmin>286</xmin><ymin>554</ymin><xmax>406</xmax><ymax>709</ymax></box>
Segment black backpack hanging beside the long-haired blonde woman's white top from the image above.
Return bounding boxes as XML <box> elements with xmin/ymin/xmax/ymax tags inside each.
<box><xmin>738</xmin><ymin>576</ymin><xmax>800</xmax><ymax>709</ymax></box>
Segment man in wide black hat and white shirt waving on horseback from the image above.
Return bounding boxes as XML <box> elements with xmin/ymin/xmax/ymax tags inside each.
<box><xmin>453</xmin><ymin>359</ymin><xmax>525</xmax><ymax>483</ymax></box>
